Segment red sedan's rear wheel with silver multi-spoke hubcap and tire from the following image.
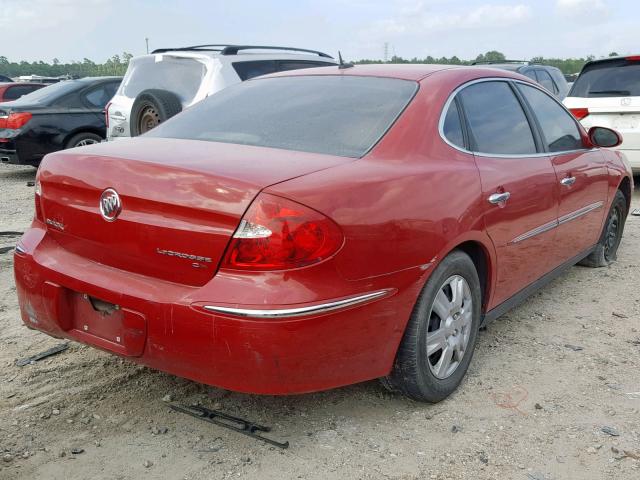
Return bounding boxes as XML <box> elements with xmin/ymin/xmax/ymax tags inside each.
<box><xmin>381</xmin><ymin>251</ymin><xmax>482</xmax><ymax>403</ymax></box>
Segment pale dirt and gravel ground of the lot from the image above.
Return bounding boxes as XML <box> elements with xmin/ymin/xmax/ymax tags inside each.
<box><xmin>0</xmin><ymin>165</ymin><xmax>640</xmax><ymax>480</ymax></box>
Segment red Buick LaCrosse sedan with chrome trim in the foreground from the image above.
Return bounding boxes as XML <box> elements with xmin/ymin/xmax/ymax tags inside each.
<box><xmin>15</xmin><ymin>65</ymin><xmax>633</xmax><ymax>402</ymax></box>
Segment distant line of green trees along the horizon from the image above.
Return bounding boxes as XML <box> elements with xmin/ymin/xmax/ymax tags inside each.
<box><xmin>0</xmin><ymin>50</ymin><xmax>618</xmax><ymax>77</ymax></box>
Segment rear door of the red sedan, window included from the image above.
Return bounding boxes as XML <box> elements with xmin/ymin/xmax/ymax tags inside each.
<box><xmin>458</xmin><ymin>80</ymin><xmax>558</xmax><ymax>308</ymax></box>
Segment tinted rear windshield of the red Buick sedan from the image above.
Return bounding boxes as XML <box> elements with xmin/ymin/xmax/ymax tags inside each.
<box><xmin>146</xmin><ymin>75</ymin><xmax>418</xmax><ymax>158</ymax></box>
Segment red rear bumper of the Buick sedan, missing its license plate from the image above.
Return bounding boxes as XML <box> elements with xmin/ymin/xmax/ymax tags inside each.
<box><xmin>14</xmin><ymin>222</ymin><xmax>425</xmax><ymax>394</ymax></box>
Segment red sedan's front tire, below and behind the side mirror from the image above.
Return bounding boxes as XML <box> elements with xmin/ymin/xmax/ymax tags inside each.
<box><xmin>579</xmin><ymin>190</ymin><xmax>627</xmax><ymax>268</ymax></box>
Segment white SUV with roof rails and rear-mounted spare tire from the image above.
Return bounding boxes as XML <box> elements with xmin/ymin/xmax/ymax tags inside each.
<box><xmin>105</xmin><ymin>45</ymin><xmax>337</xmax><ymax>140</ymax></box>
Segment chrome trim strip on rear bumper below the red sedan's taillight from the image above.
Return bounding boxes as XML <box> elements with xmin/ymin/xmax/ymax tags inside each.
<box><xmin>203</xmin><ymin>289</ymin><xmax>392</xmax><ymax>318</ymax></box>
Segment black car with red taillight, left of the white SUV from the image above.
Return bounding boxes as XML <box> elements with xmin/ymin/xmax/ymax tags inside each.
<box><xmin>0</xmin><ymin>77</ymin><xmax>122</xmax><ymax>166</ymax></box>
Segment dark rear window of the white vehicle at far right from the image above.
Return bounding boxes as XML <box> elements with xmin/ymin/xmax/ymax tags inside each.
<box><xmin>569</xmin><ymin>59</ymin><xmax>640</xmax><ymax>98</ymax></box>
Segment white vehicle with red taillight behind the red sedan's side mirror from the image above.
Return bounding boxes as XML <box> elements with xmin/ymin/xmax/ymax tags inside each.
<box><xmin>564</xmin><ymin>55</ymin><xmax>640</xmax><ymax>174</ymax></box>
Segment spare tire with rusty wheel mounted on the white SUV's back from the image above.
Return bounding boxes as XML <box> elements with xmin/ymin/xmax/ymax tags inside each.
<box><xmin>129</xmin><ymin>90</ymin><xmax>182</xmax><ymax>137</ymax></box>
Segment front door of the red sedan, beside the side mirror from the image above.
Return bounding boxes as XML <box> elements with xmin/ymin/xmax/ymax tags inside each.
<box><xmin>517</xmin><ymin>83</ymin><xmax>608</xmax><ymax>265</ymax></box>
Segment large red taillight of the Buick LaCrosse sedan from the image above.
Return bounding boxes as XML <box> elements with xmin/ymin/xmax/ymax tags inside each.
<box><xmin>222</xmin><ymin>194</ymin><xmax>343</xmax><ymax>270</ymax></box>
